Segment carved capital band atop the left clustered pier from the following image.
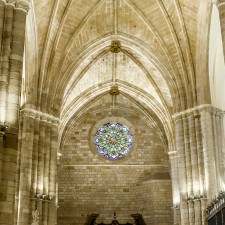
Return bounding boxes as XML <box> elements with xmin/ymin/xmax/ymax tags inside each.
<box><xmin>20</xmin><ymin>108</ymin><xmax>59</xmax><ymax>125</ymax></box>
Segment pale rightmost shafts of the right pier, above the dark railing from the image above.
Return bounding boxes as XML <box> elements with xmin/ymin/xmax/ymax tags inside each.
<box><xmin>199</xmin><ymin>105</ymin><xmax>225</xmax><ymax>199</ymax></box>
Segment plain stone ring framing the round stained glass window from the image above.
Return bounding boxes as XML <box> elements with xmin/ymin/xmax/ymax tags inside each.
<box><xmin>90</xmin><ymin>117</ymin><xmax>136</xmax><ymax>162</ymax></box>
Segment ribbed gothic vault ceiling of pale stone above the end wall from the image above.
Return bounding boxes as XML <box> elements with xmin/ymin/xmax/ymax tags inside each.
<box><xmin>23</xmin><ymin>0</ymin><xmax>213</xmax><ymax>144</ymax></box>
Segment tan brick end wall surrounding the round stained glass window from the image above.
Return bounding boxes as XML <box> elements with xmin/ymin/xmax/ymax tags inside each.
<box><xmin>58</xmin><ymin>110</ymin><xmax>172</xmax><ymax>225</ymax></box>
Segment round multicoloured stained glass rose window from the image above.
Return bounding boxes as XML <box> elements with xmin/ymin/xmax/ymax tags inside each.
<box><xmin>95</xmin><ymin>122</ymin><xmax>133</xmax><ymax>159</ymax></box>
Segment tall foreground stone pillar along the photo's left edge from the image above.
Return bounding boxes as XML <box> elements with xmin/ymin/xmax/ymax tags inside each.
<box><xmin>0</xmin><ymin>0</ymin><xmax>28</xmax><ymax>224</ymax></box>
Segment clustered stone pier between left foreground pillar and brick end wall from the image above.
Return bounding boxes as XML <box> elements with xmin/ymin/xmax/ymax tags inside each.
<box><xmin>17</xmin><ymin>109</ymin><xmax>58</xmax><ymax>225</ymax></box>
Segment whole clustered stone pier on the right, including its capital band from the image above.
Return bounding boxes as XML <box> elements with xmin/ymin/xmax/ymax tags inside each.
<box><xmin>172</xmin><ymin>105</ymin><xmax>225</xmax><ymax>225</ymax></box>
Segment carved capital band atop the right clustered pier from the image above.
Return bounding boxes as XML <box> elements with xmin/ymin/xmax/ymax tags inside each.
<box><xmin>172</xmin><ymin>104</ymin><xmax>225</xmax><ymax>120</ymax></box>
